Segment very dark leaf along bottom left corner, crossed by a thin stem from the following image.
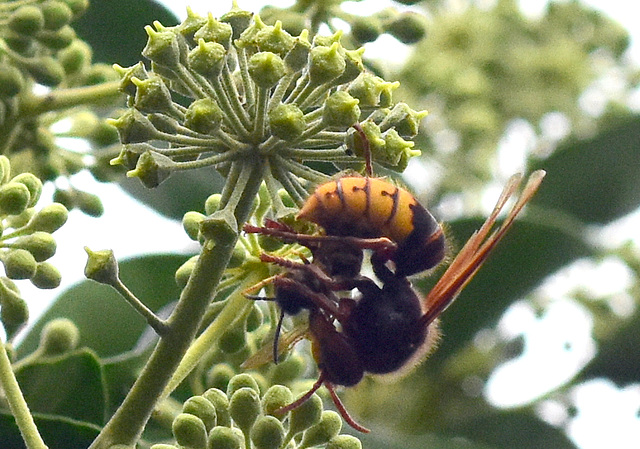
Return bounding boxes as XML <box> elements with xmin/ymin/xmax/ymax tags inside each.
<box><xmin>0</xmin><ymin>413</ymin><xmax>100</xmax><ymax>449</ymax></box>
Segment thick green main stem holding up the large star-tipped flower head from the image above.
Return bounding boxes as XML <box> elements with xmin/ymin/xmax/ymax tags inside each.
<box><xmin>90</xmin><ymin>160</ymin><xmax>262</xmax><ymax>449</ymax></box>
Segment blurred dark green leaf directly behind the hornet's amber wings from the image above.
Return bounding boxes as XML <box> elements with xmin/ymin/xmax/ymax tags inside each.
<box><xmin>417</xmin><ymin>216</ymin><xmax>592</xmax><ymax>359</ymax></box>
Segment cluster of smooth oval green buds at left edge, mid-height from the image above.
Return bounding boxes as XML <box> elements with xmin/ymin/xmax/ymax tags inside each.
<box><xmin>0</xmin><ymin>155</ymin><xmax>68</xmax><ymax>334</ymax></box>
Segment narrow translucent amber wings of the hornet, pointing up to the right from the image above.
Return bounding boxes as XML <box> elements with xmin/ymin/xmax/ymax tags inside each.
<box><xmin>422</xmin><ymin>170</ymin><xmax>546</xmax><ymax>325</ymax></box>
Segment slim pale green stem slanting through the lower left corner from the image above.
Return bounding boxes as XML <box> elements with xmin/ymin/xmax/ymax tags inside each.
<box><xmin>0</xmin><ymin>342</ymin><xmax>47</xmax><ymax>449</ymax></box>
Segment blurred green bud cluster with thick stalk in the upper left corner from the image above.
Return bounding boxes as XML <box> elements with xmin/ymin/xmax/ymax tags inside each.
<box><xmin>0</xmin><ymin>0</ymin><xmax>117</xmax><ymax>215</ymax></box>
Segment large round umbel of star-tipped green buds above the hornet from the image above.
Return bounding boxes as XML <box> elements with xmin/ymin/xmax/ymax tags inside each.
<box><xmin>111</xmin><ymin>7</ymin><xmax>424</xmax><ymax>212</ymax></box>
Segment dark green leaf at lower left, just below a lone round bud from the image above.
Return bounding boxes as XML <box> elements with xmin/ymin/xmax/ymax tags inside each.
<box><xmin>16</xmin><ymin>349</ymin><xmax>106</xmax><ymax>425</ymax></box>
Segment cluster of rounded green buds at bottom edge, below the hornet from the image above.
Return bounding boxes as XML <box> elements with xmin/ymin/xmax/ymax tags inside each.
<box><xmin>152</xmin><ymin>374</ymin><xmax>362</xmax><ymax>449</ymax></box>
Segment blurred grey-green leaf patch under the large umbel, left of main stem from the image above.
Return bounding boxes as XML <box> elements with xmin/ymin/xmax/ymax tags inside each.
<box><xmin>120</xmin><ymin>167</ymin><xmax>224</xmax><ymax>220</ymax></box>
